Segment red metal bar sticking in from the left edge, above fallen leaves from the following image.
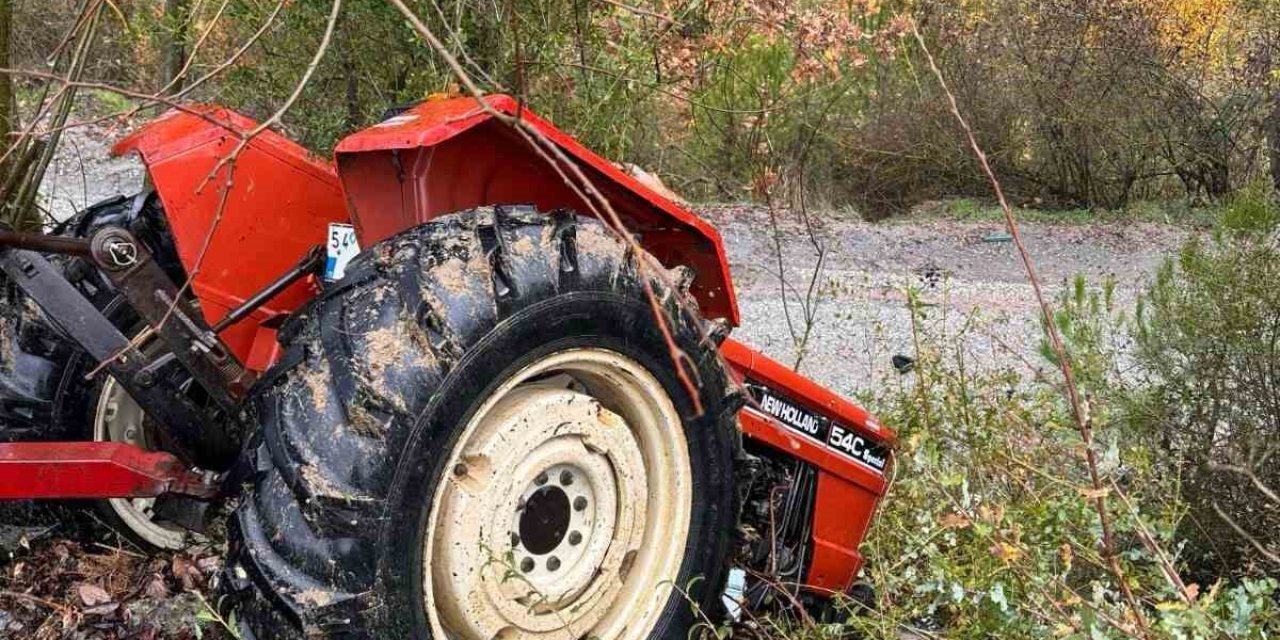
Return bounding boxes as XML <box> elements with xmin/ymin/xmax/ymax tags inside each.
<box><xmin>0</xmin><ymin>442</ymin><xmax>219</xmax><ymax>499</ymax></box>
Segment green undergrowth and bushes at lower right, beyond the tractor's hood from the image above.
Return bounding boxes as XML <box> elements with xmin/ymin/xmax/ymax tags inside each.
<box><xmin>737</xmin><ymin>188</ymin><xmax>1280</xmax><ymax>640</ymax></box>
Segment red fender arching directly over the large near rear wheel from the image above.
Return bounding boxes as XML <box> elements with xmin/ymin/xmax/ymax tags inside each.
<box><xmin>334</xmin><ymin>95</ymin><xmax>739</xmax><ymax>326</ymax></box>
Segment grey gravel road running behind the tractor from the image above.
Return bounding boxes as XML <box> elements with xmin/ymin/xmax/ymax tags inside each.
<box><xmin>41</xmin><ymin>123</ymin><xmax>1188</xmax><ymax>394</ymax></box>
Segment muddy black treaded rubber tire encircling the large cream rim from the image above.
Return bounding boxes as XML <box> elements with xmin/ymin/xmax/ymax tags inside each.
<box><xmin>225</xmin><ymin>207</ymin><xmax>741</xmax><ymax>639</ymax></box>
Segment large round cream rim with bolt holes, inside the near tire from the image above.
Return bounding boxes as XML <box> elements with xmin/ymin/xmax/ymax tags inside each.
<box><xmin>424</xmin><ymin>348</ymin><xmax>692</xmax><ymax>640</ymax></box>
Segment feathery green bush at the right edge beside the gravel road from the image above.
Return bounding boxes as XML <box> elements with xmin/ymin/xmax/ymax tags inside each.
<box><xmin>1126</xmin><ymin>187</ymin><xmax>1280</xmax><ymax>576</ymax></box>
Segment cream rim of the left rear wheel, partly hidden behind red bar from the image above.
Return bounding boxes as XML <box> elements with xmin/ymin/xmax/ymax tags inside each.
<box><xmin>93</xmin><ymin>378</ymin><xmax>186</xmax><ymax>549</ymax></box>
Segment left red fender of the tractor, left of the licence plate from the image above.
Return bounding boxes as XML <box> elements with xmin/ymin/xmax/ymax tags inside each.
<box><xmin>111</xmin><ymin>106</ymin><xmax>348</xmax><ymax>370</ymax></box>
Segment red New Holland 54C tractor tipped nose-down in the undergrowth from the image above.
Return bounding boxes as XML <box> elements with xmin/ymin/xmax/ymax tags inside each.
<box><xmin>0</xmin><ymin>96</ymin><xmax>893</xmax><ymax>640</ymax></box>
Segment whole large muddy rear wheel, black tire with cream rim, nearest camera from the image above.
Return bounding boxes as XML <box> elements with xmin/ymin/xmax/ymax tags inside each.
<box><xmin>224</xmin><ymin>207</ymin><xmax>741</xmax><ymax>640</ymax></box>
